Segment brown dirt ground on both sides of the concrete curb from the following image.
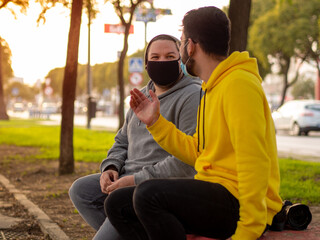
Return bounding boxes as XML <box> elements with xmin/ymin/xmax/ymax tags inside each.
<box><xmin>0</xmin><ymin>145</ymin><xmax>99</xmax><ymax>240</ymax></box>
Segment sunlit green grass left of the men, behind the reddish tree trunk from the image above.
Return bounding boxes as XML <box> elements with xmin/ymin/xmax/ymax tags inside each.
<box><xmin>0</xmin><ymin>119</ymin><xmax>115</xmax><ymax>162</ymax></box>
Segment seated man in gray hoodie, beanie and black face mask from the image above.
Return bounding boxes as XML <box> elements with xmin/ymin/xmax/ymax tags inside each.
<box><xmin>69</xmin><ymin>34</ymin><xmax>201</xmax><ymax>240</ymax></box>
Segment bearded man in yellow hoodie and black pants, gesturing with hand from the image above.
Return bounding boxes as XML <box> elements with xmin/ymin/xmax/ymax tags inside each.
<box><xmin>106</xmin><ymin>7</ymin><xmax>282</xmax><ymax>240</ymax></box>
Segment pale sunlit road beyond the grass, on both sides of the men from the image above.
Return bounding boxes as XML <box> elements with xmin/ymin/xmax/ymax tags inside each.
<box><xmin>8</xmin><ymin>111</ymin><xmax>320</xmax><ymax>162</ymax></box>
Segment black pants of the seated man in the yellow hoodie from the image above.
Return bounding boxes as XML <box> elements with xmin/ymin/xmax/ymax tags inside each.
<box><xmin>105</xmin><ymin>179</ymin><xmax>239</xmax><ymax>240</ymax></box>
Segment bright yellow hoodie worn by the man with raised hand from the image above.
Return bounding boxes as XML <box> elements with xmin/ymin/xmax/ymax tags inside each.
<box><xmin>148</xmin><ymin>52</ymin><xmax>282</xmax><ymax>240</ymax></box>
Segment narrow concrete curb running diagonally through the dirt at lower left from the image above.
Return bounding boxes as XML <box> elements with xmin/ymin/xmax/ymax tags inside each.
<box><xmin>0</xmin><ymin>174</ymin><xmax>70</xmax><ymax>240</ymax></box>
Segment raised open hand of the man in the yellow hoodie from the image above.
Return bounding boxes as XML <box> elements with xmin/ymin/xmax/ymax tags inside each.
<box><xmin>130</xmin><ymin>88</ymin><xmax>160</xmax><ymax>126</ymax></box>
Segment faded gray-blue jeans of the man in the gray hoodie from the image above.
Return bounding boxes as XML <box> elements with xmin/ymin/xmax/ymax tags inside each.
<box><xmin>69</xmin><ymin>174</ymin><xmax>122</xmax><ymax>240</ymax></box>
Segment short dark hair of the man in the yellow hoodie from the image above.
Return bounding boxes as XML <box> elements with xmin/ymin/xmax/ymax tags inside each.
<box><xmin>182</xmin><ymin>6</ymin><xmax>231</xmax><ymax>56</ymax></box>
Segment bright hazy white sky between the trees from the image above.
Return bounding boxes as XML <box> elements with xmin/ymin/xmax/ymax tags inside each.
<box><xmin>0</xmin><ymin>0</ymin><xmax>229</xmax><ymax>85</ymax></box>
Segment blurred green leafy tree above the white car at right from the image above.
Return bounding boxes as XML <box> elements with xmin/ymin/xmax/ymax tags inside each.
<box><xmin>249</xmin><ymin>0</ymin><xmax>320</xmax><ymax>104</ymax></box>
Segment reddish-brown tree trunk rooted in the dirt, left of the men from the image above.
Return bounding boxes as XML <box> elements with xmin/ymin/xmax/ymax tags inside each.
<box><xmin>59</xmin><ymin>0</ymin><xmax>83</xmax><ymax>175</ymax></box>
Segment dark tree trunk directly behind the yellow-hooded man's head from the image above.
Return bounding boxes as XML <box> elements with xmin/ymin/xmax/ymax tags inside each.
<box><xmin>228</xmin><ymin>0</ymin><xmax>251</xmax><ymax>54</ymax></box>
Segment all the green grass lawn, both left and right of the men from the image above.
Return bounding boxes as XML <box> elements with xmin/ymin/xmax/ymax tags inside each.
<box><xmin>0</xmin><ymin>119</ymin><xmax>320</xmax><ymax>204</ymax></box>
